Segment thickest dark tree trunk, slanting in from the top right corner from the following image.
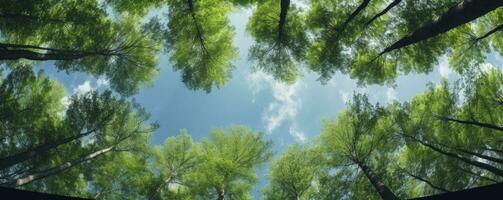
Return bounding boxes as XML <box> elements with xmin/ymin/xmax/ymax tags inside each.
<box><xmin>379</xmin><ymin>0</ymin><xmax>503</xmax><ymax>55</ymax></box>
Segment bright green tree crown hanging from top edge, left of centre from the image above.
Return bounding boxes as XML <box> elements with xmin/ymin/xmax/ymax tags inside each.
<box><xmin>167</xmin><ymin>0</ymin><xmax>237</xmax><ymax>92</ymax></box>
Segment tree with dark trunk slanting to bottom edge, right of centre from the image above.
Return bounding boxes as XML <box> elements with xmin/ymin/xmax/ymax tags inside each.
<box><xmin>321</xmin><ymin>95</ymin><xmax>398</xmax><ymax>199</ymax></box>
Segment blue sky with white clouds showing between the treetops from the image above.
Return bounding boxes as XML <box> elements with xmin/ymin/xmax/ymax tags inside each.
<box><xmin>39</xmin><ymin>5</ymin><xmax>503</xmax><ymax>198</ymax></box>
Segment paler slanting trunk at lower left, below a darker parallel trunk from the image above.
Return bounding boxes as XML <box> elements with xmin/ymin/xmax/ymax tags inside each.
<box><xmin>3</xmin><ymin>146</ymin><xmax>115</xmax><ymax>187</ymax></box>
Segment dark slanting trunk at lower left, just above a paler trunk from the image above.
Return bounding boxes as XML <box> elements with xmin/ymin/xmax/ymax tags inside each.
<box><xmin>0</xmin><ymin>131</ymin><xmax>93</xmax><ymax>170</ymax></box>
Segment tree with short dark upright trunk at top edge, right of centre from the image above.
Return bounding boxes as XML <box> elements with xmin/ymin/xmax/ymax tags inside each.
<box><xmin>247</xmin><ymin>0</ymin><xmax>308</xmax><ymax>83</ymax></box>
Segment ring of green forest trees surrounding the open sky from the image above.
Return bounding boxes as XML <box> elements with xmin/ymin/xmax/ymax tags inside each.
<box><xmin>0</xmin><ymin>0</ymin><xmax>503</xmax><ymax>200</ymax></box>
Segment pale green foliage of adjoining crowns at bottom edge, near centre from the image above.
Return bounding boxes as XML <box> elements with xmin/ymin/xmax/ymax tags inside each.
<box><xmin>151</xmin><ymin>126</ymin><xmax>271</xmax><ymax>199</ymax></box>
